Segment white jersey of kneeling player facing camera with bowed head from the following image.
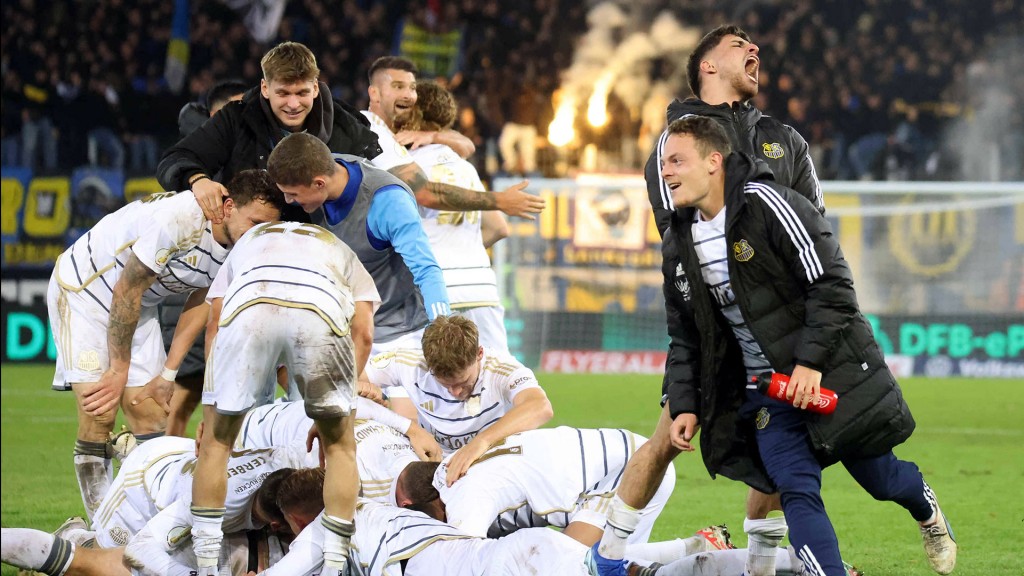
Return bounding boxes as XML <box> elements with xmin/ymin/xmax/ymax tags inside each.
<box><xmin>366</xmin><ymin>348</ymin><xmax>541</xmax><ymax>454</ymax></box>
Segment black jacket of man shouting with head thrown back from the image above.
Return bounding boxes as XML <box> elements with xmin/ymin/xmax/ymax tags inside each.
<box><xmin>644</xmin><ymin>98</ymin><xmax>825</xmax><ymax>237</ymax></box>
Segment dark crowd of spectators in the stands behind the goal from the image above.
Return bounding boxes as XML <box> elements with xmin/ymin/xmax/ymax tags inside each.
<box><xmin>0</xmin><ymin>0</ymin><xmax>1024</xmax><ymax>180</ymax></box>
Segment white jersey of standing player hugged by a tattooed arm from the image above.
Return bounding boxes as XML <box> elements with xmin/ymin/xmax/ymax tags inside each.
<box><xmin>410</xmin><ymin>145</ymin><xmax>500</xmax><ymax>310</ymax></box>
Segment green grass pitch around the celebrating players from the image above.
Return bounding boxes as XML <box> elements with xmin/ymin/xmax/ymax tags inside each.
<box><xmin>0</xmin><ymin>365</ymin><xmax>1024</xmax><ymax>576</ymax></box>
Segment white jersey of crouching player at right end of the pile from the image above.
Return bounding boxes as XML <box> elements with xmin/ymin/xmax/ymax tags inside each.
<box><xmin>433</xmin><ymin>426</ymin><xmax>646</xmax><ymax>537</ymax></box>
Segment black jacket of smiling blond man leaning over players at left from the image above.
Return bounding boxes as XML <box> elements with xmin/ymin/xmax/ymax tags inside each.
<box><xmin>157</xmin><ymin>82</ymin><xmax>381</xmax><ymax>191</ymax></box>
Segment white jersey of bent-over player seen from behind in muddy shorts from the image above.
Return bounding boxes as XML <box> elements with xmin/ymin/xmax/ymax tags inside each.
<box><xmin>207</xmin><ymin>222</ymin><xmax>381</xmax><ymax>336</ymax></box>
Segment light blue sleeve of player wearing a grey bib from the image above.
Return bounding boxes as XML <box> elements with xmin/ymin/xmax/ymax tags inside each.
<box><xmin>367</xmin><ymin>186</ymin><xmax>450</xmax><ymax>321</ymax></box>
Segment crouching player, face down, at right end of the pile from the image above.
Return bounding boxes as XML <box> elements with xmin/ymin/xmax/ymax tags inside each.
<box><xmin>393</xmin><ymin>426</ymin><xmax>676</xmax><ymax>545</ymax></box>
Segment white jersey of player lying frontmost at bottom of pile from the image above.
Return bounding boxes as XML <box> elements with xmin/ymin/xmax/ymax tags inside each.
<box><xmin>260</xmin><ymin>498</ymin><xmax>475</xmax><ymax>576</ymax></box>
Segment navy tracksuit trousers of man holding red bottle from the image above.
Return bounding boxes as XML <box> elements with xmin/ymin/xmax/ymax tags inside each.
<box><xmin>741</xmin><ymin>392</ymin><xmax>934</xmax><ymax>576</ymax></box>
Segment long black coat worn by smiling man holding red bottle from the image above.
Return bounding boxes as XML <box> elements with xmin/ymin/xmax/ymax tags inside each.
<box><xmin>663</xmin><ymin>153</ymin><xmax>914</xmax><ymax>492</ymax></box>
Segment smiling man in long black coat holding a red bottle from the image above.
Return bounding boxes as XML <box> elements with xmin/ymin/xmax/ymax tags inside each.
<box><xmin>595</xmin><ymin>116</ymin><xmax>956</xmax><ymax>576</ymax></box>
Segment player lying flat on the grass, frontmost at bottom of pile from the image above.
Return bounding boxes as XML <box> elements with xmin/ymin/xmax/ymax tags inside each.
<box><xmin>241</xmin><ymin>467</ymin><xmax>823</xmax><ymax>576</ymax></box>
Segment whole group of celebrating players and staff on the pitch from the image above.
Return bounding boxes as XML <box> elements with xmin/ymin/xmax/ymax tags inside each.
<box><xmin>2</xmin><ymin>27</ymin><xmax>955</xmax><ymax>576</ymax></box>
